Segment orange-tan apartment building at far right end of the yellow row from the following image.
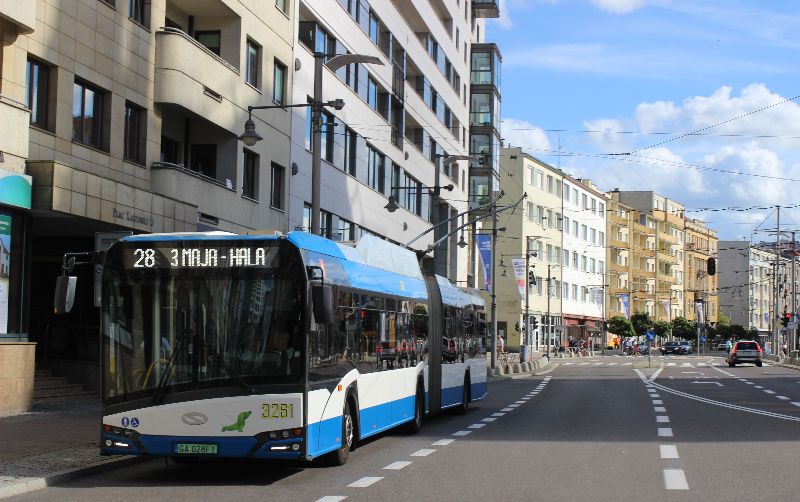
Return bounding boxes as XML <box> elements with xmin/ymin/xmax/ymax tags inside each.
<box><xmin>684</xmin><ymin>218</ymin><xmax>719</xmax><ymax>325</ymax></box>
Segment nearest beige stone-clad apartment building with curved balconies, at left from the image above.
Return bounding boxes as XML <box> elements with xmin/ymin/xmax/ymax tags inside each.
<box><xmin>0</xmin><ymin>0</ymin><xmax>296</xmax><ymax>387</ymax></box>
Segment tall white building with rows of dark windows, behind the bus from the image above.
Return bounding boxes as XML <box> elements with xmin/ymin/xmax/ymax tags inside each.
<box><xmin>289</xmin><ymin>0</ymin><xmax>499</xmax><ymax>285</ymax></box>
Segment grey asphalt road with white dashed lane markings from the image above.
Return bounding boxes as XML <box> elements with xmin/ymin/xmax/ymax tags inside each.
<box><xmin>14</xmin><ymin>354</ymin><xmax>800</xmax><ymax>502</ymax></box>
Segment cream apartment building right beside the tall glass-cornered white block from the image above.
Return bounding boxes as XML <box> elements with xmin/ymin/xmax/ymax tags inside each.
<box><xmin>496</xmin><ymin>148</ymin><xmax>564</xmax><ymax>350</ymax></box>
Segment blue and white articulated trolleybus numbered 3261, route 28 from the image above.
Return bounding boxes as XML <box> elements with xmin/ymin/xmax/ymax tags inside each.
<box><xmin>57</xmin><ymin>232</ymin><xmax>487</xmax><ymax>465</ymax></box>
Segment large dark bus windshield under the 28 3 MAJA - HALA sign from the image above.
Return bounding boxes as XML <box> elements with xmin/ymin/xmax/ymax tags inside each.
<box><xmin>102</xmin><ymin>240</ymin><xmax>305</xmax><ymax>404</ymax></box>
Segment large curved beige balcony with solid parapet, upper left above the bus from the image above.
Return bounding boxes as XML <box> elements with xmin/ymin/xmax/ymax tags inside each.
<box><xmin>154</xmin><ymin>28</ymin><xmax>244</xmax><ymax>133</ymax></box>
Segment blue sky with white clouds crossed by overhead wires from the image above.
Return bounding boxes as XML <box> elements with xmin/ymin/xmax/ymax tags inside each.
<box><xmin>486</xmin><ymin>0</ymin><xmax>800</xmax><ymax>242</ymax></box>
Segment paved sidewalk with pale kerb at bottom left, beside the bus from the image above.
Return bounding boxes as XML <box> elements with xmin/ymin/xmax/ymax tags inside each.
<box><xmin>0</xmin><ymin>398</ymin><xmax>137</xmax><ymax>499</ymax></box>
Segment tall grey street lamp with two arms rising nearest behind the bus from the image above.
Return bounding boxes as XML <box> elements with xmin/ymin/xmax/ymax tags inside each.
<box><xmin>239</xmin><ymin>52</ymin><xmax>383</xmax><ymax>235</ymax></box>
